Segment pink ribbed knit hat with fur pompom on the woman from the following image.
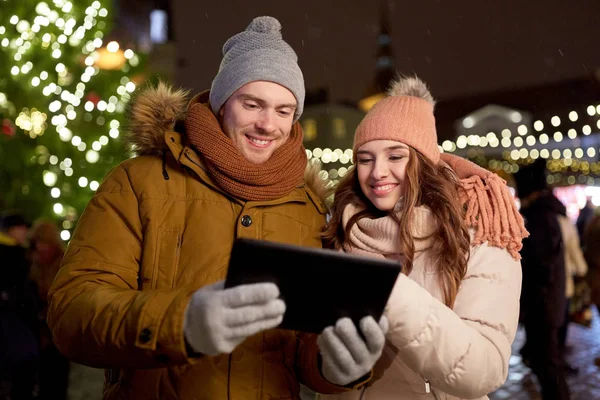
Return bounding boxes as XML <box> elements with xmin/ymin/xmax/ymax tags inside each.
<box><xmin>353</xmin><ymin>77</ymin><xmax>440</xmax><ymax>164</ymax></box>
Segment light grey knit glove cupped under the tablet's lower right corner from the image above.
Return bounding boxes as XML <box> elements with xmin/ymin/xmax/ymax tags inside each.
<box><xmin>317</xmin><ymin>316</ymin><xmax>389</xmax><ymax>386</ymax></box>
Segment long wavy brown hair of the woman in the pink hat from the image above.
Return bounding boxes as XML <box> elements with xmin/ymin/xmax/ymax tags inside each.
<box><xmin>323</xmin><ymin>147</ymin><xmax>471</xmax><ymax>308</ymax></box>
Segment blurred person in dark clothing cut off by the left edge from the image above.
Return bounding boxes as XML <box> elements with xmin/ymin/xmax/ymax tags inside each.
<box><xmin>0</xmin><ymin>211</ymin><xmax>38</xmax><ymax>399</ymax></box>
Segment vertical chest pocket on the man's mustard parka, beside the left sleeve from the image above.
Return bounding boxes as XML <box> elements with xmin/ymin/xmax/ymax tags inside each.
<box><xmin>151</xmin><ymin>228</ymin><xmax>182</xmax><ymax>289</ymax></box>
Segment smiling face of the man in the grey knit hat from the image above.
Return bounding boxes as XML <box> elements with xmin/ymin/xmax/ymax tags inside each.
<box><xmin>219</xmin><ymin>81</ymin><xmax>297</xmax><ymax>164</ymax></box>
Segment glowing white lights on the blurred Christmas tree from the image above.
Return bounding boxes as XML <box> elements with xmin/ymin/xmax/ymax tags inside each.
<box><xmin>0</xmin><ymin>0</ymin><xmax>140</xmax><ymax>240</ymax></box>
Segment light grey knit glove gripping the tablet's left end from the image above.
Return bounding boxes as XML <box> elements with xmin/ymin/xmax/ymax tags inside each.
<box><xmin>183</xmin><ymin>281</ymin><xmax>285</xmax><ymax>356</ymax></box>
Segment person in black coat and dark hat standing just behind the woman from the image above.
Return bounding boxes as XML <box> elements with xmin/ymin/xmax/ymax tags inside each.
<box><xmin>514</xmin><ymin>159</ymin><xmax>569</xmax><ymax>400</ymax></box>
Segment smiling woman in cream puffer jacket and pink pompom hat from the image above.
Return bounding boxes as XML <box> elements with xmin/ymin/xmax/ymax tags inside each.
<box><xmin>324</xmin><ymin>78</ymin><xmax>527</xmax><ymax>400</ymax></box>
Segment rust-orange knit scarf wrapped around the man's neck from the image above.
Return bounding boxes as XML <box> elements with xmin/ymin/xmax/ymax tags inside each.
<box><xmin>185</xmin><ymin>103</ymin><xmax>307</xmax><ymax>201</ymax></box>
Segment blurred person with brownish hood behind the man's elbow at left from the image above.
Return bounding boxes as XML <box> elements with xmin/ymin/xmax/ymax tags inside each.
<box><xmin>29</xmin><ymin>220</ymin><xmax>69</xmax><ymax>400</ymax></box>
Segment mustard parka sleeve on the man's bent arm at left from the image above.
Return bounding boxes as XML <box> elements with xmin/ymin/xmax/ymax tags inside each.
<box><xmin>48</xmin><ymin>166</ymin><xmax>197</xmax><ymax>368</ymax></box>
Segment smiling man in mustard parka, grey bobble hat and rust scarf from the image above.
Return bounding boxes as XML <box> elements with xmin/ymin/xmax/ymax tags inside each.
<box><xmin>48</xmin><ymin>17</ymin><xmax>387</xmax><ymax>400</ymax></box>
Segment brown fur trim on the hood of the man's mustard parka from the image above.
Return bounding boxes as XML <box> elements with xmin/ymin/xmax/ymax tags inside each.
<box><xmin>125</xmin><ymin>82</ymin><xmax>333</xmax><ymax>205</ymax></box>
